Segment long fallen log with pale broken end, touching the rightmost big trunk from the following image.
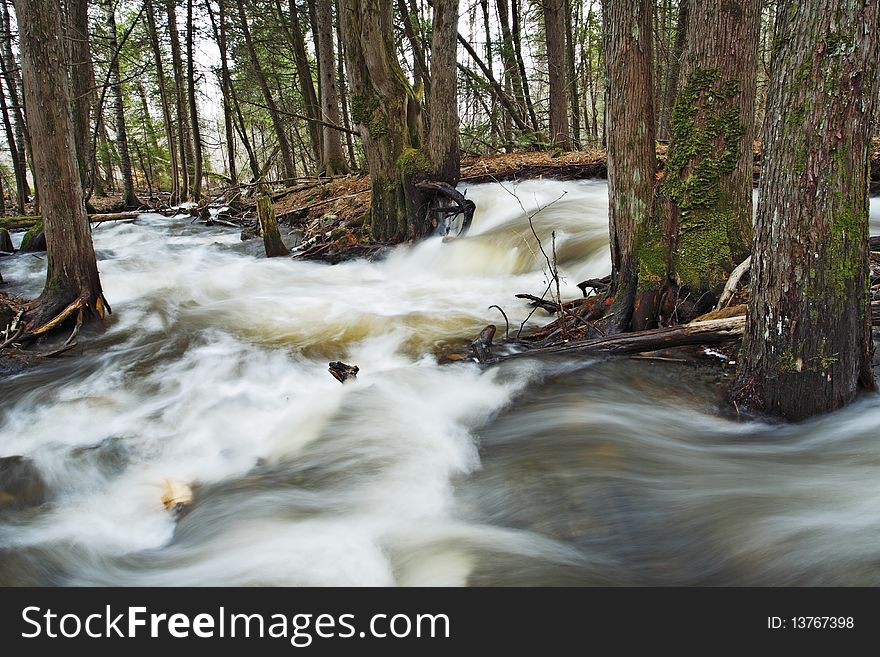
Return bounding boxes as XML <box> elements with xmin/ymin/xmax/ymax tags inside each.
<box><xmin>485</xmin><ymin>316</ymin><xmax>746</xmax><ymax>364</ymax></box>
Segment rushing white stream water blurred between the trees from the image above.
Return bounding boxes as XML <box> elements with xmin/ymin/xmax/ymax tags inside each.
<box><xmin>0</xmin><ymin>181</ymin><xmax>880</xmax><ymax>585</ymax></box>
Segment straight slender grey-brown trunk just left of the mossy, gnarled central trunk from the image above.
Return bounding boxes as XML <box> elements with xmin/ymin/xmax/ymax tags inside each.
<box><xmin>316</xmin><ymin>0</ymin><xmax>348</xmax><ymax>176</ymax></box>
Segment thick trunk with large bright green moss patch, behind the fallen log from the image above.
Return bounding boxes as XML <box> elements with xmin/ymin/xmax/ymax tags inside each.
<box><xmin>649</xmin><ymin>0</ymin><xmax>761</xmax><ymax>321</ymax></box>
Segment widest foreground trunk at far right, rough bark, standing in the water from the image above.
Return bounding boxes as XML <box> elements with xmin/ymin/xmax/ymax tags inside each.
<box><xmin>735</xmin><ymin>0</ymin><xmax>880</xmax><ymax>420</ymax></box>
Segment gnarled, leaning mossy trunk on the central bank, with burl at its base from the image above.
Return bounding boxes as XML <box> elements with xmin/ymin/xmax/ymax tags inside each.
<box><xmin>341</xmin><ymin>0</ymin><xmax>431</xmax><ymax>242</ymax></box>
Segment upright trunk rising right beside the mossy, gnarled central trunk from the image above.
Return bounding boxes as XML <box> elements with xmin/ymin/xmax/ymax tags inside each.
<box><xmin>427</xmin><ymin>0</ymin><xmax>461</xmax><ymax>186</ymax></box>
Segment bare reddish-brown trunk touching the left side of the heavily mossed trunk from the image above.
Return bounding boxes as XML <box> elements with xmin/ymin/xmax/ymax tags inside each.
<box><xmin>604</xmin><ymin>0</ymin><xmax>665</xmax><ymax>330</ymax></box>
